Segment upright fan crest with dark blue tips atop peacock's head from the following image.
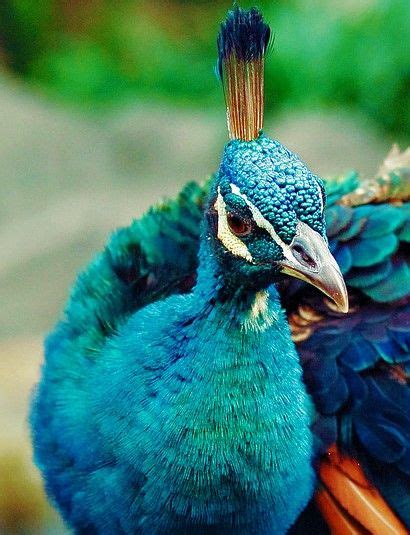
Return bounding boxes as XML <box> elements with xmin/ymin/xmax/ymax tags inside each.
<box><xmin>217</xmin><ymin>6</ymin><xmax>271</xmax><ymax>141</ymax></box>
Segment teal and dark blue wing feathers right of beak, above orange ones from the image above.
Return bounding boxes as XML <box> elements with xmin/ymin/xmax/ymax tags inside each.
<box><xmin>282</xmin><ymin>172</ymin><xmax>410</xmax><ymax>526</ymax></box>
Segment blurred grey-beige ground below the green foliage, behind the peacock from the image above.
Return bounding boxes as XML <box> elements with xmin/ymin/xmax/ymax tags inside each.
<box><xmin>0</xmin><ymin>79</ymin><xmax>391</xmax><ymax>533</ymax></box>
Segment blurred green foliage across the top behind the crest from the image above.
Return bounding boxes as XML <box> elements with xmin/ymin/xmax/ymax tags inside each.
<box><xmin>0</xmin><ymin>0</ymin><xmax>410</xmax><ymax>136</ymax></box>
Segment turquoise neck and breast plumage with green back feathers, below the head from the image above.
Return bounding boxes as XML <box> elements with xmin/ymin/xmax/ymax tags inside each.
<box><xmin>32</xmin><ymin>178</ymin><xmax>314</xmax><ymax>533</ymax></box>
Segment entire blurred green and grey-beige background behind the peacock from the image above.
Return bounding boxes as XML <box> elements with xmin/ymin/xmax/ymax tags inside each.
<box><xmin>0</xmin><ymin>0</ymin><xmax>410</xmax><ymax>534</ymax></box>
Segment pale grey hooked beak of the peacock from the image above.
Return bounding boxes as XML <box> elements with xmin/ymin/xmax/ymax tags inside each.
<box><xmin>280</xmin><ymin>221</ymin><xmax>349</xmax><ymax>312</ymax></box>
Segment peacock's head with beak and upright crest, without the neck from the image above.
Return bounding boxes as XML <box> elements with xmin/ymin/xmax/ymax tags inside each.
<box><xmin>203</xmin><ymin>7</ymin><xmax>348</xmax><ymax>312</ymax></box>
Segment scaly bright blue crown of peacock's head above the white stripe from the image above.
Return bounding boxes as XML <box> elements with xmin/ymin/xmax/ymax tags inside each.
<box><xmin>218</xmin><ymin>134</ymin><xmax>325</xmax><ymax>239</ymax></box>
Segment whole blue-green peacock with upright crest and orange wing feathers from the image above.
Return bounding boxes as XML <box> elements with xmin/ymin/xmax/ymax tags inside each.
<box><xmin>30</xmin><ymin>6</ymin><xmax>410</xmax><ymax>535</ymax></box>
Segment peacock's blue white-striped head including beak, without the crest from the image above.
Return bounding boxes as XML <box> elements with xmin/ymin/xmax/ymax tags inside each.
<box><xmin>203</xmin><ymin>133</ymin><xmax>347</xmax><ymax>310</ymax></box>
